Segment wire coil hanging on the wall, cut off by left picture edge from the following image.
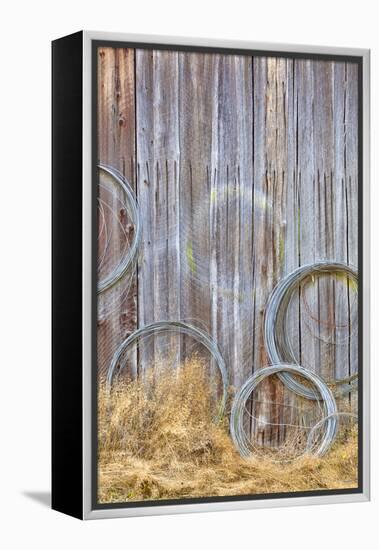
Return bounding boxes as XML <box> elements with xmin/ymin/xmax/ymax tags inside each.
<box><xmin>97</xmin><ymin>164</ymin><xmax>142</xmax><ymax>294</ymax></box>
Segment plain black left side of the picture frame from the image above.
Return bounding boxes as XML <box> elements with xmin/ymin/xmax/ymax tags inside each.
<box><xmin>51</xmin><ymin>31</ymin><xmax>83</xmax><ymax>519</ymax></box>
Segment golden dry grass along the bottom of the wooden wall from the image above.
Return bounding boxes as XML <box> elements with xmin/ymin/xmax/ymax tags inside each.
<box><xmin>98</xmin><ymin>360</ymin><xmax>357</xmax><ymax>503</ymax></box>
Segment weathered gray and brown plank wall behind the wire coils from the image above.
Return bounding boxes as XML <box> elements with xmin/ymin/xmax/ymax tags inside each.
<box><xmin>98</xmin><ymin>48</ymin><xmax>358</xmax><ymax>440</ymax></box>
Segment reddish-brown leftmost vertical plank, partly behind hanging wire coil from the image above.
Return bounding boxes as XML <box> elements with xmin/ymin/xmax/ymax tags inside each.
<box><xmin>97</xmin><ymin>48</ymin><xmax>136</xmax><ymax>375</ymax></box>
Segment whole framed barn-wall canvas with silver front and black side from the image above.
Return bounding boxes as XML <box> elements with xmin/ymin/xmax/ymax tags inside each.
<box><xmin>52</xmin><ymin>32</ymin><xmax>370</xmax><ymax>519</ymax></box>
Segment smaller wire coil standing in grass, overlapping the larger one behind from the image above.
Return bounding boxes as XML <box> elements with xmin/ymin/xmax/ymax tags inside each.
<box><xmin>230</xmin><ymin>364</ymin><xmax>337</xmax><ymax>458</ymax></box>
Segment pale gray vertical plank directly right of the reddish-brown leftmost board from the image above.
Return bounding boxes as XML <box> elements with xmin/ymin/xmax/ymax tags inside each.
<box><xmin>136</xmin><ymin>50</ymin><xmax>180</xmax><ymax>370</ymax></box>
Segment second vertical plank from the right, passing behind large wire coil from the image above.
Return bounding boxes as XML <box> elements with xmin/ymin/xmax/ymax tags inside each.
<box><xmin>296</xmin><ymin>60</ymin><xmax>335</xmax><ymax>388</ymax></box>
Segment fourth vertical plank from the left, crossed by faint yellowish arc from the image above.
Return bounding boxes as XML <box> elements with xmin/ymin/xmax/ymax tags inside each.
<box><xmin>213</xmin><ymin>56</ymin><xmax>253</xmax><ymax>387</ymax></box>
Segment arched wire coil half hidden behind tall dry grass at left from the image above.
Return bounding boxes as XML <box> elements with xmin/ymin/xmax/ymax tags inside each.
<box><xmin>107</xmin><ymin>321</ymin><xmax>228</xmax><ymax>420</ymax></box>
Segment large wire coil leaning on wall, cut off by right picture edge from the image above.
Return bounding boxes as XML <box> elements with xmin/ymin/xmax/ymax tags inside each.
<box><xmin>264</xmin><ymin>261</ymin><xmax>358</xmax><ymax>400</ymax></box>
